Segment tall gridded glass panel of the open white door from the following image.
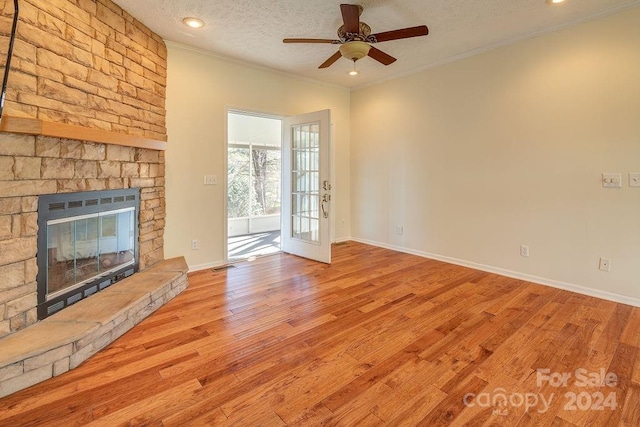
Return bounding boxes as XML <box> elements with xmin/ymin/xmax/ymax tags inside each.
<box><xmin>291</xmin><ymin>124</ymin><xmax>320</xmax><ymax>243</ymax></box>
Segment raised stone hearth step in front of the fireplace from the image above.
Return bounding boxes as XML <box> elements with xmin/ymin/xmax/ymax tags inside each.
<box><xmin>0</xmin><ymin>257</ymin><xmax>188</xmax><ymax>397</ymax></box>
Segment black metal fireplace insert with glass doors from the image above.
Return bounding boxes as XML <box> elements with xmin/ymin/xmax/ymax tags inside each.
<box><xmin>37</xmin><ymin>189</ymin><xmax>140</xmax><ymax>319</ymax></box>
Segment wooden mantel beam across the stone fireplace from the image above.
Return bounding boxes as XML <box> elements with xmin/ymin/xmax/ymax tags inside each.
<box><xmin>0</xmin><ymin>115</ymin><xmax>167</xmax><ymax>151</ymax></box>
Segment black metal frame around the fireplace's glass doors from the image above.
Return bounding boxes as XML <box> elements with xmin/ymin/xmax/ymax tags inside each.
<box><xmin>37</xmin><ymin>188</ymin><xmax>140</xmax><ymax>320</ymax></box>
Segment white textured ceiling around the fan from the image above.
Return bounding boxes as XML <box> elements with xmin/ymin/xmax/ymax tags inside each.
<box><xmin>115</xmin><ymin>0</ymin><xmax>640</xmax><ymax>88</ymax></box>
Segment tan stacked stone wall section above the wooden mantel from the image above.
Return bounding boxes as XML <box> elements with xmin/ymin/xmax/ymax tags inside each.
<box><xmin>0</xmin><ymin>0</ymin><xmax>167</xmax><ymax>141</ymax></box>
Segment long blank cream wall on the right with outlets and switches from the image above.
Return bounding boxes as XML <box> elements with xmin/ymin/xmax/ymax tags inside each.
<box><xmin>351</xmin><ymin>8</ymin><xmax>640</xmax><ymax>304</ymax></box>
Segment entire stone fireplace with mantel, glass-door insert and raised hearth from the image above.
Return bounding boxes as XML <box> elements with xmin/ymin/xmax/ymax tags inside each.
<box><xmin>0</xmin><ymin>0</ymin><xmax>187</xmax><ymax>397</ymax></box>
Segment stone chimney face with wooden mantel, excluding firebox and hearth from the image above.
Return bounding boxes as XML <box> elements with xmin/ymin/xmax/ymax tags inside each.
<box><xmin>0</xmin><ymin>0</ymin><xmax>167</xmax><ymax>338</ymax></box>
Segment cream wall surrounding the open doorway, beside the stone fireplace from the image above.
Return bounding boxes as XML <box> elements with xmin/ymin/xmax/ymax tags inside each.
<box><xmin>165</xmin><ymin>44</ymin><xmax>351</xmax><ymax>269</ymax></box>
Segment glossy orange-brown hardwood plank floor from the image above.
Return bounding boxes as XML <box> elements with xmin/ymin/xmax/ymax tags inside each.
<box><xmin>0</xmin><ymin>242</ymin><xmax>640</xmax><ymax>426</ymax></box>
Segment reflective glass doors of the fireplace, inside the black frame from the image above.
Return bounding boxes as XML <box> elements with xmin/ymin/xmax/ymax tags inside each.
<box><xmin>47</xmin><ymin>207</ymin><xmax>136</xmax><ymax>300</ymax></box>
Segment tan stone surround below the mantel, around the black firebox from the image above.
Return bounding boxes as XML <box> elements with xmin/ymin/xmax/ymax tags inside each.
<box><xmin>0</xmin><ymin>133</ymin><xmax>165</xmax><ymax>337</ymax></box>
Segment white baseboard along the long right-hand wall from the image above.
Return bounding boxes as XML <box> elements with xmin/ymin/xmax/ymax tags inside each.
<box><xmin>351</xmin><ymin>238</ymin><xmax>640</xmax><ymax>307</ymax></box>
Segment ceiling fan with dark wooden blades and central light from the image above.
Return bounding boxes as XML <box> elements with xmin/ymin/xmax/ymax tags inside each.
<box><xmin>282</xmin><ymin>4</ymin><xmax>429</xmax><ymax>68</ymax></box>
